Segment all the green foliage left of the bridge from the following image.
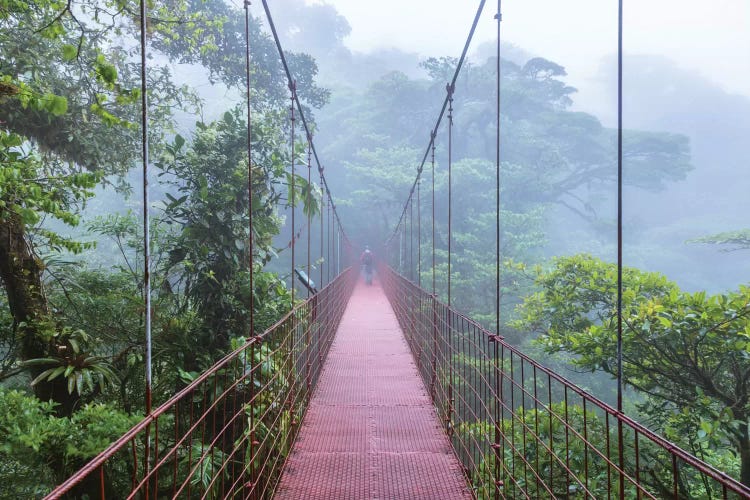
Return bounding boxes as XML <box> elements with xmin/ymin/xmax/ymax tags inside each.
<box><xmin>0</xmin><ymin>0</ymin><xmax>328</xmax><ymax>498</ymax></box>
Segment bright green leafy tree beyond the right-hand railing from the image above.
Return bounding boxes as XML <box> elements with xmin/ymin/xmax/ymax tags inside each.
<box><xmin>516</xmin><ymin>255</ymin><xmax>750</xmax><ymax>484</ymax></box>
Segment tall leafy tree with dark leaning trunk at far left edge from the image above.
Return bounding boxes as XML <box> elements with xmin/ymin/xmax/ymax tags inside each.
<box><xmin>0</xmin><ymin>0</ymin><xmax>207</xmax><ymax>415</ymax></box>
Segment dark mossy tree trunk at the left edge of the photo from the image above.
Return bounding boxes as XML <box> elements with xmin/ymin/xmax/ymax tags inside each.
<box><xmin>0</xmin><ymin>209</ymin><xmax>78</xmax><ymax>415</ymax></box>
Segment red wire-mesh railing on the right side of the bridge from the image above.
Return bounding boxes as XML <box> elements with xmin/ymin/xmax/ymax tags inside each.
<box><xmin>380</xmin><ymin>266</ymin><xmax>750</xmax><ymax>499</ymax></box>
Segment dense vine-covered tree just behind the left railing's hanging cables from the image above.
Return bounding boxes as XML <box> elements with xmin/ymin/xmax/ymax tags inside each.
<box><xmin>157</xmin><ymin>108</ymin><xmax>318</xmax><ymax>360</ymax></box>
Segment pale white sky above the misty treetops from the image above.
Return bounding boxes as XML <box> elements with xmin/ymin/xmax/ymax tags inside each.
<box><xmin>306</xmin><ymin>0</ymin><xmax>750</xmax><ymax>96</ymax></box>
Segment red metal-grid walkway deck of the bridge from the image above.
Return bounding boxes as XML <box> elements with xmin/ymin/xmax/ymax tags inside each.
<box><xmin>275</xmin><ymin>280</ymin><xmax>472</xmax><ymax>500</ymax></box>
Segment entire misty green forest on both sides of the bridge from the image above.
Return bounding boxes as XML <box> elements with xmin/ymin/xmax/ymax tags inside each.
<box><xmin>0</xmin><ymin>0</ymin><xmax>750</xmax><ymax>498</ymax></box>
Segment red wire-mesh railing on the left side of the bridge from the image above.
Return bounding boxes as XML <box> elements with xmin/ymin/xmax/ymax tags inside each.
<box><xmin>46</xmin><ymin>269</ymin><xmax>357</xmax><ymax>499</ymax></box>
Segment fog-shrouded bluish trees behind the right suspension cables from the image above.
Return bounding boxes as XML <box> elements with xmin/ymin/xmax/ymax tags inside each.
<box><xmin>322</xmin><ymin>51</ymin><xmax>692</xmax><ymax>348</ymax></box>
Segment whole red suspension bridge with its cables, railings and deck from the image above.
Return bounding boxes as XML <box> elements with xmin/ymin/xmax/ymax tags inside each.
<box><xmin>42</xmin><ymin>0</ymin><xmax>750</xmax><ymax>499</ymax></box>
